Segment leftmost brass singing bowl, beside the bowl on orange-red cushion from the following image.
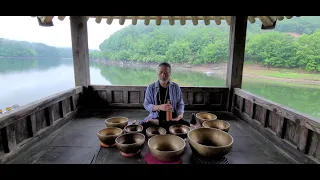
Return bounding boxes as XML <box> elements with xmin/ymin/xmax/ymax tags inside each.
<box><xmin>98</xmin><ymin>127</ymin><xmax>123</xmax><ymax>145</ymax></box>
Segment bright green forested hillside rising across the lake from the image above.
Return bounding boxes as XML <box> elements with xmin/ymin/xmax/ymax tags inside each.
<box><xmin>90</xmin><ymin>16</ymin><xmax>320</xmax><ymax>71</ymax></box>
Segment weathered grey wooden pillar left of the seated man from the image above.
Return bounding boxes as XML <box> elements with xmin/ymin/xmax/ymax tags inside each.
<box><xmin>70</xmin><ymin>16</ymin><xmax>90</xmax><ymax>87</ymax></box>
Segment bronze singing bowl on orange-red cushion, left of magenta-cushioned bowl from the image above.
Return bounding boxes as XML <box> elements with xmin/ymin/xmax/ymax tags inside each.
<box><xmin>116</xmin><ymin>133</ymin><xmax>145</xmax><ymax>154</ymax></box>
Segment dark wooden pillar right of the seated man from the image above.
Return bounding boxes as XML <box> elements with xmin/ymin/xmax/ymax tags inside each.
<box><xmin>227</xmin><ymin>16</ymin><xmax>248</xmax><ymax>111</ymax></box>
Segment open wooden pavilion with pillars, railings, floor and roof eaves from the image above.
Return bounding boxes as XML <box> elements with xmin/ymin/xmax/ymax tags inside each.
<box><xmin>0</xmin><ymin>16</ymin><xmax>320</xmax><ymax>163</ymax></box>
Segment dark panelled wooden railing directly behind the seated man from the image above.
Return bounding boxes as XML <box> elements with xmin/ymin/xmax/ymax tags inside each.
<box><xmin>86</xmin><ymin>85</ymin><xmax>228</xmax><ymax>111</ymax></box>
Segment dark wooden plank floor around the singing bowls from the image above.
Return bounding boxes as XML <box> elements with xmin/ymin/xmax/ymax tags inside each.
<box><xmin>8</xmin><ymin>109</ymin><xmax>297</xmax><ymax>164</ymax></box>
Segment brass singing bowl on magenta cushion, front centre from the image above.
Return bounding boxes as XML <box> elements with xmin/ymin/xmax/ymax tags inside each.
<box><xmin>148</xmin><ymin>134</ymin><xmax>186</xmax><ymax>162</ymax></box>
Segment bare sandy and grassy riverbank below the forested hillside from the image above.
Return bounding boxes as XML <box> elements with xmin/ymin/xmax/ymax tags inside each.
<box><xmin>93</xmin><ymin>60</ymin><xmax>320</xmax><ymax>86</ymax></box>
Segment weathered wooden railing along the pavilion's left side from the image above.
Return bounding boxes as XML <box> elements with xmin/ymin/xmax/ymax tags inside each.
<box><xmin>0</xmin><ymin>87</ymin><xmax>83</xmax><ymax>163</ymax></box>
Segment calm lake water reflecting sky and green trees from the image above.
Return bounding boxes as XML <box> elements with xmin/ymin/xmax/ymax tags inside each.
<box><xmin>0</xmin><ymin>58</ymin><xmax>320</xmax><ymax>121</ymax></box>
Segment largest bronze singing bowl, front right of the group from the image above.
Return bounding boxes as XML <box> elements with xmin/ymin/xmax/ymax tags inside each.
<box><xmin>188</xmin><ymin>127</ymin><xmax>233</xmax><ymax>158</ymax></box>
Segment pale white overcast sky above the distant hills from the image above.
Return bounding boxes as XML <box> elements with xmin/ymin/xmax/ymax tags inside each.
<box><xmin>0</xmin><ymin>16</ymin><xmax>131</xmax><ymax>49</ymax></box>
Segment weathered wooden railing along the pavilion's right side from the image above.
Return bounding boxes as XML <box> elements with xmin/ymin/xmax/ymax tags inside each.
<box><xmin>232</xmin><ymin>88</ymin><xmax>320</xmax><ymax>163</ymax></box>
